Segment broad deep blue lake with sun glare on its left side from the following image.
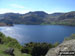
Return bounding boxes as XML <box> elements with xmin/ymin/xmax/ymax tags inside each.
<box><xmin>0</xmin><ymin>24</ymin><xmax>75</xmax><ymax>44</ymax></box>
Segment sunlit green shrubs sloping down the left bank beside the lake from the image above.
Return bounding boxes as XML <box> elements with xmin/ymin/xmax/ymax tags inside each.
<box><xmin>0</xmin><ymin>32</ymin><xmax>21</xmax><ymax>49</ymax></box>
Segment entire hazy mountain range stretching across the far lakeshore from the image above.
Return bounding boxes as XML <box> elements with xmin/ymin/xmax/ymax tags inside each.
<box><xmin>0</xmin><ymin>11</ymin><xmax>75</xmax><ymax>25</ymax></box>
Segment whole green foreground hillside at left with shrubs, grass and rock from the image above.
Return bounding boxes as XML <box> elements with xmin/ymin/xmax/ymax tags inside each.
<box><xmin>0</xmin><ymin>32</ymin><xmax>31</xmax><ymax>56</ymax></box>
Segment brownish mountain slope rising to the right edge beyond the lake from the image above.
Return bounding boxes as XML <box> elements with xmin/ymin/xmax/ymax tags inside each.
<box><xmin>56</xmin><ymin>11</ymin><xmax>75</xmax><ymax>25</ymax></box>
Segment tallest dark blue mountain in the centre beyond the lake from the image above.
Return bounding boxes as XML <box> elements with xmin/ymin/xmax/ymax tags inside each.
<box><xmin>22</xmin><ymin>11</ymin><xmax>48</xmax><ymax>24</ymax></box>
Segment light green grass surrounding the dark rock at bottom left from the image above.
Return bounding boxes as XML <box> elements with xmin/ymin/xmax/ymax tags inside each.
<box><xmin>0</xmin><ymin>44</ymin><xmax>30</xmax><ymax>56</ymax></box>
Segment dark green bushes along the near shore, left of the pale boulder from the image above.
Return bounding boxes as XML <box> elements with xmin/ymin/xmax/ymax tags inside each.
<box><xmin>21</xmin><ymin>42</ymin><xmax>59</xmax><ymax>56</ymax></box>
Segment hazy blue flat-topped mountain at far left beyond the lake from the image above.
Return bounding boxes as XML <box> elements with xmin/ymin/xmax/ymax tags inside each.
<box><xmin>0</xmin><ymin>13</ymin><xmax>20</xmax><ymax>24</ymax></box>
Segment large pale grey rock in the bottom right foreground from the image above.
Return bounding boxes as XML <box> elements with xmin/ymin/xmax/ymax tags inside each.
<box><xmin>45</xmin><ymin>40</ymin><xmax>75</xmax><ymax>56</ymax></box>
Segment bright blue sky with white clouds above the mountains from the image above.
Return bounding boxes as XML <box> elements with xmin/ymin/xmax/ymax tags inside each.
<box><xmin>0</xmin><ymin>0</ymin><xmax>75</xmax><ymax>14</ymax></box>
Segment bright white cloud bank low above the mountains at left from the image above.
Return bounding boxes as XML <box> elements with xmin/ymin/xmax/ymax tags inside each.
<box><xmin>0</xmin><ymin>8</ymin><xmax>29</xmax><ymax>14</ymax></box>
